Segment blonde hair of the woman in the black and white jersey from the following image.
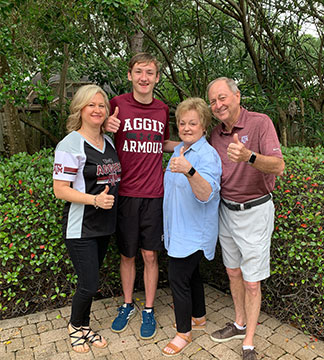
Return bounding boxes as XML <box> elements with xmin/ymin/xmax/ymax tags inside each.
<box><xmin>66</xmin><ymin>85</ymin><xmax>110</xmax><ymax>133</ymax></box>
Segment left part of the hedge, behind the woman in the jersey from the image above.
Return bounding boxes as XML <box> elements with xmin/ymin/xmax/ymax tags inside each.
<box><xmin>0</xmin><ymin>150</ymin><xmax>119</xmax><ymax>318</ymax></box>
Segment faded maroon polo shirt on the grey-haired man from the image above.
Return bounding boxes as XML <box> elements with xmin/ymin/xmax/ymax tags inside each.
<box><xmin>210</xmin><ymin>107</ymin><xmax>282</xmax><ymax>203</ymax></box>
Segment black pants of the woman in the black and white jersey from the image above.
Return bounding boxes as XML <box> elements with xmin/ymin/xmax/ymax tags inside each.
<box><xmin>65</xmin><ymin>236</ymin><xmax>109</xmax><ymax>327</ymax></box>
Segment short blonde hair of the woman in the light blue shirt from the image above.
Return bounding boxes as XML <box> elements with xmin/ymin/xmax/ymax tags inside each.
<box><xmin>175</xmin><ymin>97</ymin><xmax>212</xmax><ymax>130</ymax></box>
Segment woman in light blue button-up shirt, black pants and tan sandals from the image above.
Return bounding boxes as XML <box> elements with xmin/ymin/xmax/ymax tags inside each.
<box><xmin>162</xmin><ymin>98</ymin><xmax>221</xmax><ymax>356</ymax></box>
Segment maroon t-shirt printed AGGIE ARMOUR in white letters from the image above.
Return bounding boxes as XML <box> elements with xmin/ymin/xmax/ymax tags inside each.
<box><xmin>110</xmin><ymin>93</ymin><xmax>169</xmax><ymax>198</ymax></box>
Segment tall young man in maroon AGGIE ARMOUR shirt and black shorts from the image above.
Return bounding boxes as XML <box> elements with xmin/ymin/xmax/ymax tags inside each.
<box><xmin>106</xmin><ymin>53</ymin><xmax>178</xmax><ymax>339</ymax></box>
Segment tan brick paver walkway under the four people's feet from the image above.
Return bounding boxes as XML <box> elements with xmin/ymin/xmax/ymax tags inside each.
<box><xmin>0</xmin><ymin>286</ymin><xmax>324</xmax><ymax>360</ymax></box>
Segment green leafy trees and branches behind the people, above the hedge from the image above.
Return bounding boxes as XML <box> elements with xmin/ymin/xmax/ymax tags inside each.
<box><xmin>0</xmin><ymin>0</ymin><xmax>324</xmax><ymax>155</ymax></box>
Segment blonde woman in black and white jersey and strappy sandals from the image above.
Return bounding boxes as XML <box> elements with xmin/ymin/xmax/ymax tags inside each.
<box><xmin>53</xmin><ymin>85</ymin><xmax>121</xmax><ymax>353</ymax></box>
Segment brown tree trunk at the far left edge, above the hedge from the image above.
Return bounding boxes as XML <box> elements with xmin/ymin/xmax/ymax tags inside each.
<box><xmin>0</xmin><ymin>54</ymin><xmax>27</xmax><ymax>156</ymax></box>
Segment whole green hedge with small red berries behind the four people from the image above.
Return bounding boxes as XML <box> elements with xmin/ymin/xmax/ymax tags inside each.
<box><xmin>0</xmin><ymin>147</ymin><xmax>324</xmax><ymax>339</ymax></box>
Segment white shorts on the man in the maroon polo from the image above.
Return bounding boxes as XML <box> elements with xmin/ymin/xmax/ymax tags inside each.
<box><xmin>219</xmin><ymin>195</ymin><xmax>274</xmax><ymax>282</ymax></box>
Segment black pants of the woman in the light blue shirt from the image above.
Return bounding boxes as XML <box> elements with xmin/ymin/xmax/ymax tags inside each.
<box><xmin>169</xmin><ymin>250</ymin><xmax>206</xmax><ymax>333</ymax></box>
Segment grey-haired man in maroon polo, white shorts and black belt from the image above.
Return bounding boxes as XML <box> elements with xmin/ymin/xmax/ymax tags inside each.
<box><xmin>207</xmin><ymin>78</ymin><xmax>285</xmax><ymax>360</ymax></box>
